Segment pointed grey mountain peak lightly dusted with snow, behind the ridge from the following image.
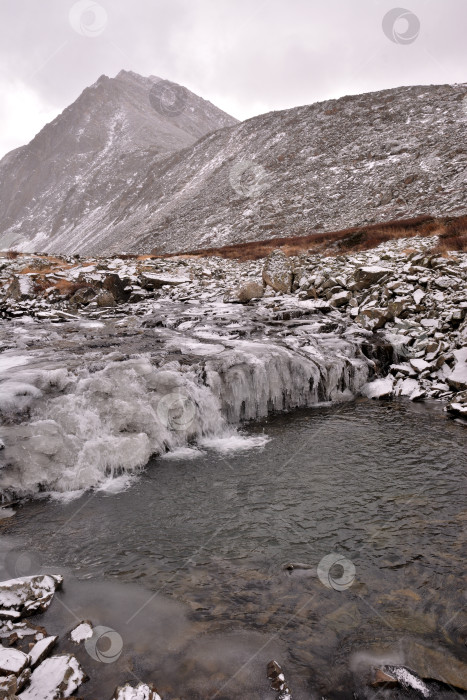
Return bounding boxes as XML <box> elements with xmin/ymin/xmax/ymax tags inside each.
<box><xmin>0</xmin><ymin>71</ymin><xmax>237</xmax><ymax>250</ymax></box>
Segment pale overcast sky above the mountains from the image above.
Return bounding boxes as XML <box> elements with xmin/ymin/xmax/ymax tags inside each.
<box><xmin>0</xmin><ymin>0</ymin><xmax>467</xmax><ymax>157</ymax></box>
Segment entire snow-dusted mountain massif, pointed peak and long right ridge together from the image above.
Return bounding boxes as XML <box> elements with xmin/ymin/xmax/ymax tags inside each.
<box><xmin>0</xmin><ymin>77</ymin><xmax>467</xmax><ymax>254</ymax></box>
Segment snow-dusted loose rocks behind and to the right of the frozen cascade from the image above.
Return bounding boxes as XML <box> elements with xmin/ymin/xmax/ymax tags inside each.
<box><xmin>0</xmin><ymin>232</ymin><xmax>467</xmax><ymax>424</ymax></box>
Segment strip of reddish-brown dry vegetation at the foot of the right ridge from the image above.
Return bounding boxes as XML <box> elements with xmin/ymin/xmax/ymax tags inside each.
<box><xmin>159</xmin><ymin>216</ymin><xmax>467</xmax><ymax>260</ymax></box>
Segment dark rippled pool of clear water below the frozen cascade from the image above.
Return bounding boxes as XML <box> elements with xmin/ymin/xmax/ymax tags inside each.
<box><xmin>1</xmin><ymin>401</ymin><xmax>467</xmax><ymax>700</ymax></box>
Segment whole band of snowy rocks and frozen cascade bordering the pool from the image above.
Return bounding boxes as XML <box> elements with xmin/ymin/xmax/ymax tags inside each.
<box><xmin>0</xmin><ymin>238</ymin><xmax>467</xmax><ymax>499</ymax></box>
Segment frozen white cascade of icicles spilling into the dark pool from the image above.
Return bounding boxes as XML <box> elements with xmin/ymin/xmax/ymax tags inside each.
<box><xmin>0</xmin><ymin>328</ymin><xmax>368</xmax><ymax>500</ymax></box>
